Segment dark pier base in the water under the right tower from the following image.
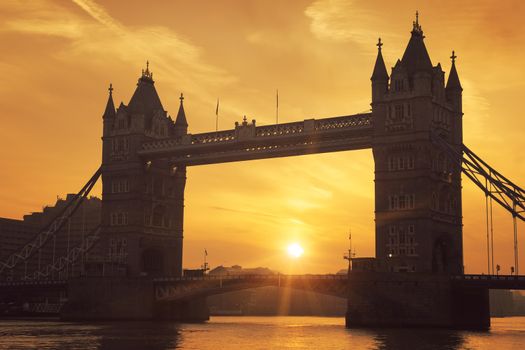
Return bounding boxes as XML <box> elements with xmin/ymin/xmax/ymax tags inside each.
<box><xmin>346</xmin><ymin>272</ymin><xmax>490</xmax><ymax>330</ymax></box>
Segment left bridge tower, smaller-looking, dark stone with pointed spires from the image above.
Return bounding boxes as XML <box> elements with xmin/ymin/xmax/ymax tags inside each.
<box><xmin>98</xmin><ymin>64</ymin><xmax>188</xmax><ymax>276</ymax></box>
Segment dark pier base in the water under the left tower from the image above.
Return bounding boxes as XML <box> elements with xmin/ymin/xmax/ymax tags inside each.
<box><xmin>60</xmin><ymin>277</ymin><xmax>209</xmax><ymax>322</ymax></box>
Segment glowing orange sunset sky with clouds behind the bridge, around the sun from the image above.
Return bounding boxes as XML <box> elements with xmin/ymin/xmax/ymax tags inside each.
<box><xmin>0</xmin><ymin>0</ymin><xmax>525</xmax><ymax>273</ymax></box>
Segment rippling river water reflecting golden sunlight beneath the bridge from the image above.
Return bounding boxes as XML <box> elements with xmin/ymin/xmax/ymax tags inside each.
<box><xmin>0</xmin><ymin>317</ymin><xmax>525</xmax><ymax>350</ymax></box>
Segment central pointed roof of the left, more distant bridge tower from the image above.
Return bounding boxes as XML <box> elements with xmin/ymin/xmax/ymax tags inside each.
<box><xmin>128</xmin><ymin>62</ymin><xmax>164</xmax><ymax>115</ymax></box>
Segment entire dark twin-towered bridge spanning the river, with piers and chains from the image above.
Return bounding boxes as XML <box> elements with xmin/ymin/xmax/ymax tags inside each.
<box><xmin>0</xmin><ymin>15</ymin><xmax>525</xmax><ymax>328</ymax></box>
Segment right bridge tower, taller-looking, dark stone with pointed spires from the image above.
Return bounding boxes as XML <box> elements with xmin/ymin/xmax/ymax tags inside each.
<box><xmin>371</xmin><ymin>15</ymin><xmax>463</xmax><ymax>274</ymax></box>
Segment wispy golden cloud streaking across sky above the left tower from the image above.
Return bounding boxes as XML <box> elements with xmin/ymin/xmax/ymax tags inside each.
<box><xmin>0</xmin><ymin>0</ymin><xmax>235</xmax><ymax>106</ymax></box>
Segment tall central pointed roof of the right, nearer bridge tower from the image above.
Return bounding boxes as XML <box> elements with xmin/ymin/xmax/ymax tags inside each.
<box><xmin>401</xmin><ymin>12</ymin><xmax>432</xmax><ymax>75</ymax></box>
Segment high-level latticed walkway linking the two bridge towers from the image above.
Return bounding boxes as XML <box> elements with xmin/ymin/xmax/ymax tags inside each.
<box><xmin>138</xmin><ymin>113</ymin><xmax>373</xmax><ymax>165</ymax></box>
